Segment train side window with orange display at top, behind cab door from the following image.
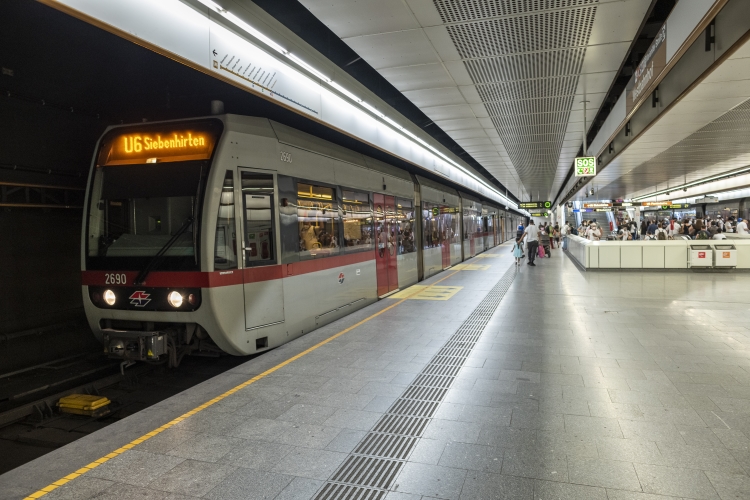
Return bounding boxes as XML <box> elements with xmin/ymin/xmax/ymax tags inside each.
<box><xmin>297</xmin><ymin>183</ymin><xmax>339</xmax><ymax>259</ymax></box>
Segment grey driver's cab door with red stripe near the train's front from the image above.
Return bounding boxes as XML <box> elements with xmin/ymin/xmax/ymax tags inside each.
<box><xmin>240</xmin><ymin>169</ymin><xmax>284</xmax><ymax>330</ymax></box>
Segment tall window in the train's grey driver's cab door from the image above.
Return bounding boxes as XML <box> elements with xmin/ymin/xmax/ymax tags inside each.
<box><xmin>242</xmin><ymin>172</ymin><xmax>276</xmax><ymax>267</ymax></box>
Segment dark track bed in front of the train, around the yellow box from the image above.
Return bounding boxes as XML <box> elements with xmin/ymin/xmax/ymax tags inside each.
<box><xmin>0</xmin><ymin>348</ymin><xmax>249</xmax><ymax>474</ymax></box>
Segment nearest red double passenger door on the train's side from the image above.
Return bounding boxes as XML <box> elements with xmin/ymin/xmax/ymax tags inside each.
<box><xmin>373</xmin><ymin>193</ymin><xmax>398</xmax><ymax>296</ymax></box>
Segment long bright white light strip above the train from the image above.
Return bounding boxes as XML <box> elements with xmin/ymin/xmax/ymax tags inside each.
<box><xmin>198</xmin><ymin>0</ymin><xmax>528</xmax><ymax>215</ymax></box>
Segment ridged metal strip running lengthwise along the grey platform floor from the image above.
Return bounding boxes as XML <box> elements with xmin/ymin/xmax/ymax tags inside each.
<box><xmin>315</xmin><ymin>266</ymin><xmax>517</xmax><ymax>500</ymax></box>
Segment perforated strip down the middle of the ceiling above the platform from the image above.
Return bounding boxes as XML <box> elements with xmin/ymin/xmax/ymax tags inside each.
<box><xmin>434</xmin><ymin>0</ymin><xmax>598</xmax><ymax>197</ymax></box>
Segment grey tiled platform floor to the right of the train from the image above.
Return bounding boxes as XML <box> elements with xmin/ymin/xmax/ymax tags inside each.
<box><xmin>0</xmin><ymin>246</ymin><xmax>750</xmax><ymax>500</ymax></box>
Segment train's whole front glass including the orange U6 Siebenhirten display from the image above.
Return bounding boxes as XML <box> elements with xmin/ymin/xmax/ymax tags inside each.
<box><xmin>86</xmin><ymin>119</ymin><xmax>223</xmax><ymax>271</ymax></box>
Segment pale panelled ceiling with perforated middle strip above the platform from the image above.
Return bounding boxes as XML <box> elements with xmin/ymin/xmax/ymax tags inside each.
<box><xmin>300</xmin><ymin>0</ymin><xmax>651</xmax><ymax>200</ymax></box>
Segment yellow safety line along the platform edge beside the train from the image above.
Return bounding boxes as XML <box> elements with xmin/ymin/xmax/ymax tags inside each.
<box><xmin>26</xmin><ymin>271</ymin><xmax>458</xmax><ymax>500</ymax></box>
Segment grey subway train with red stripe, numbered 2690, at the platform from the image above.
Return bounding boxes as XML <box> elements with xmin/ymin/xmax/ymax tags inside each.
<box><xmin>81</xmin><ymin>114</ymin><xmax>523</xmax><ymax>366</ymax></box>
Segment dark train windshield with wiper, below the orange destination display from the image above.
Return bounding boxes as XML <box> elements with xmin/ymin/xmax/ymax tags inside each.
<box><xmin>88</xmin><ymin>161</ymin><xmax>207</xmax><ymax>270</ymax></box>
